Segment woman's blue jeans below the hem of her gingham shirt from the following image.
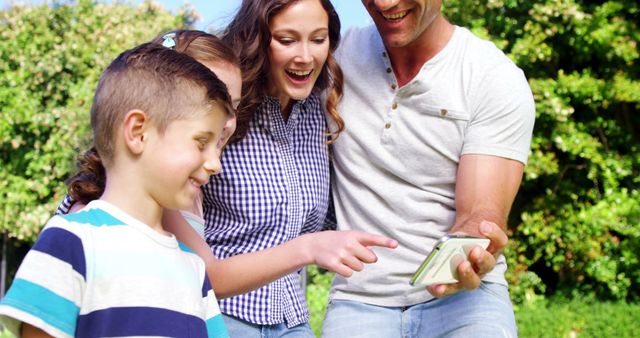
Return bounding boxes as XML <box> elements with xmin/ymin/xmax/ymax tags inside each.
<box><xmin>222</xmin><ymin>315</ymin><xmax>316</xmax><ymax>338</ymax></box>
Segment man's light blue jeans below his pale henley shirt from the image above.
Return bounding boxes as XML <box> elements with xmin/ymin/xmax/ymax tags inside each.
<box><xmin>322</xmin><ymin>282</ymin><xmax>518</xmax><ymax>338</ymax></box>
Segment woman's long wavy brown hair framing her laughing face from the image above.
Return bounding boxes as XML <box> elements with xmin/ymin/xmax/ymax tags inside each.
<box><xmin>222</xmin><ymin>0</ymin><xmax>344</xmax><ymax>142</ymax></box>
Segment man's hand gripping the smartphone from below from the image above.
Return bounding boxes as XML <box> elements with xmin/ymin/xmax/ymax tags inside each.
<box><xmin>412</xmin><ymin>221</ymin><xmax>508</xmax><ymax>297</ymax></box>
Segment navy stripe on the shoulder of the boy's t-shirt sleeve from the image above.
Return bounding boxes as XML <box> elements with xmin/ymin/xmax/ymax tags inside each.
<box><xmin>32</xmin><ymin>228</ymin><xmax>87</xmax><ymax>280</ymax></box>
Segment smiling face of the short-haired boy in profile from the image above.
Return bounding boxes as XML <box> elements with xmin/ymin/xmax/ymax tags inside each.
<box><xmin>143</xmin><ymin>103</ymin><xmax>230</xmax><ymax>209</ymax></box>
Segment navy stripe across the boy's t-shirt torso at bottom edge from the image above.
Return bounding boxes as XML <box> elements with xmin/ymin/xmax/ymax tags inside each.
<box><xmin>76</xmin><ymin>307</ymin><xmax>207</xmax><ymax>338</ymax></box>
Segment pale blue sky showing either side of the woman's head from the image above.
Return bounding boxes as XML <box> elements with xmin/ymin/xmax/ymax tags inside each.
<box><xmin>162</xmin><ymin>0</ymin><xmax>370</xmax><ymax>30</ymax></box>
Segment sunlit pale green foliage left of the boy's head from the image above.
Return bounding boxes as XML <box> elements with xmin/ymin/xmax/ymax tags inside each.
<box><xmin>0</xmin><ymin>0</ymin><xmax>194</xmax><ymax>241</ymax></box>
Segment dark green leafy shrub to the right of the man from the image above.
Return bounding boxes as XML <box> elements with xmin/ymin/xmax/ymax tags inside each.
<box><xmin>445</xmin><ymin>0</ymin><xmax>640</xmax><ymax>301</ymax></box>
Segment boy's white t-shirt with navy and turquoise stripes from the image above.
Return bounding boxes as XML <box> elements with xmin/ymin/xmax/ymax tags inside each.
<box><xmin>0</xmin><ymin>200</ymin><xmax>228</xmax><ymax>337</ymax></box>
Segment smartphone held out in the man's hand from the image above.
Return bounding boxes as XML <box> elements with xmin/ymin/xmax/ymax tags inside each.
<box><xmin>409</xmin><ymin>235</ymin><xmax>491</xmax><ymax>286</ymax></box>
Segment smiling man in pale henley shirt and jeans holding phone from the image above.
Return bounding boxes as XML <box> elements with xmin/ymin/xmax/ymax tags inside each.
<box><xmin>323</xmin><ymin>0</ymin><xmax>535</xmax><ymax>337</ymax></box>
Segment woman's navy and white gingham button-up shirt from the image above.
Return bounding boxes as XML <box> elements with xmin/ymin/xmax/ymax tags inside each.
<box><xmin>203</xmin><ymin>94</ymin><xmax>329</xmax><ymax>327</ymax></box>
